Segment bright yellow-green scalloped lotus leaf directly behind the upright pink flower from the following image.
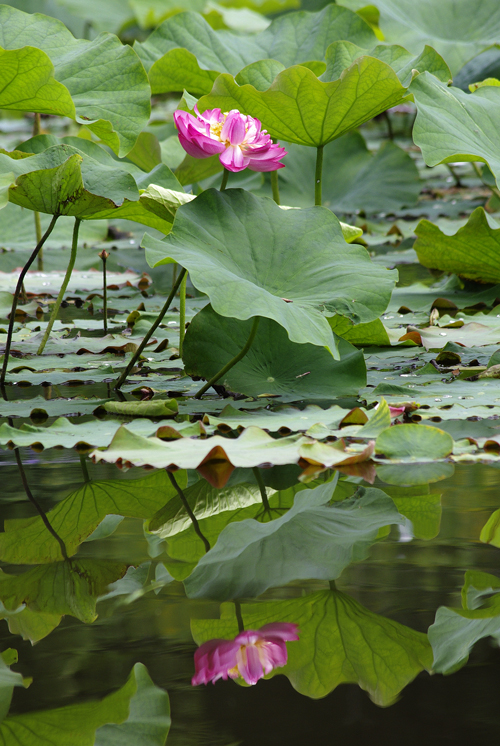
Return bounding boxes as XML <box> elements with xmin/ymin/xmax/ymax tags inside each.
<box><xmin>198</xmin><ymin>57</ymin><xmax>407</xmax><ymax>147</ymax></box>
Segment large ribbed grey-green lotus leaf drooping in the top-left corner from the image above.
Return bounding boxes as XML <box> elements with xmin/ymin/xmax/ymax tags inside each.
<box><xmin>0</xmin><ymin>5</ymin><xmax>151</xmax><ymax>156</ymax></box>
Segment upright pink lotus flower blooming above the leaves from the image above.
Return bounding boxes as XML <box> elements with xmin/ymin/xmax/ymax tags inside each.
<box><xmin>174</xmin><ymin>106</ymin><xmax>286</xmax><ymax>171</ymax></box>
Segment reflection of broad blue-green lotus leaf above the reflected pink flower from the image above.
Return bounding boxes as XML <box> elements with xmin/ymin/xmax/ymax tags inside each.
<box><xmin>184</xmin><ymin>483</ymin><xmax>405</xmax><ymax>600</ymax></box>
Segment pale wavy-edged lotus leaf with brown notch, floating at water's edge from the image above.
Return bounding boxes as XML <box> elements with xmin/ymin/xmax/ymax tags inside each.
<box><xmin>91</xmin><ymin>426</ymin><xmax>311</xmax><ymax>469</ymax></box>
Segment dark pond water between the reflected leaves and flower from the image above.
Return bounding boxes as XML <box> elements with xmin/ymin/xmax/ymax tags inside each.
<box><xmin>0</xmin><ymin>438</ymin><xmax>500</xmax><ymax>746</ymax></box>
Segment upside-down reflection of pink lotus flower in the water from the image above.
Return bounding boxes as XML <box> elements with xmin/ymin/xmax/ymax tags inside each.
<box><xmin>191</xmin><ymin>622</ymin><xmax>299</xmax><ymax>686</ymax></box>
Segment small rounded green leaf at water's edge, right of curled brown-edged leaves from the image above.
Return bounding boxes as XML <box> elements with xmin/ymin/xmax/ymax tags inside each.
<box><xmin>375</xmin><ymin>425</ymin><xmax>453</xmax><ymax>461</ymax></box>
